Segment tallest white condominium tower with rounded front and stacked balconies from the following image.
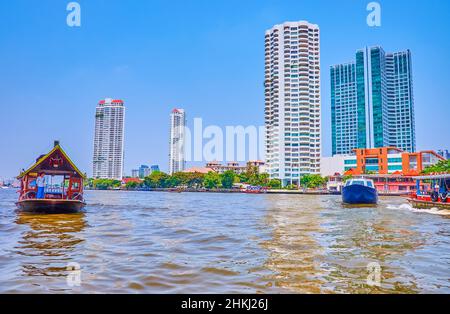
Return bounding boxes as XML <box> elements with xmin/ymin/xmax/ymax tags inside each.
<box><xmin>265</xmin><ymin>21</ymin><xmax>321</xmax><ymax>185</ymax></box>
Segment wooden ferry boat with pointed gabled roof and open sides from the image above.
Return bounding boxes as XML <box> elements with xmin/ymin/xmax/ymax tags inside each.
<box><xmin>16</xmin><ymin>141</ymin><xmax>86</xmax><ymax>213</ymax></box>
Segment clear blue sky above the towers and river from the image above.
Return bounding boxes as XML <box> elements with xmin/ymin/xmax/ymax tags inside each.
<box><xmin>0</xmin><ymin>0</ymin><xmax>450</xmax><ymax>177</ymax></box>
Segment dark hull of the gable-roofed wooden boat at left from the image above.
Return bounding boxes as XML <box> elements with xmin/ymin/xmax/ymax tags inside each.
<box><xmin>16</xmin><ymin>199</ymin><xmax>86</xmax><ymax>214</ymax></box>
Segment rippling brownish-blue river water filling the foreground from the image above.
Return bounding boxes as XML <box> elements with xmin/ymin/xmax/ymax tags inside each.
<box><xmin>0</xmin><ymin>190</ymin><xmax>450</xmax><ymax>293</ymax></box>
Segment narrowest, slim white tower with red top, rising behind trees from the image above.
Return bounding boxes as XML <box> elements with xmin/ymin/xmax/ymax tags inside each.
<box><xmin>169</xmin><ymin>109</ymin><xmax>186</xmax><ymax>174</ymax></box>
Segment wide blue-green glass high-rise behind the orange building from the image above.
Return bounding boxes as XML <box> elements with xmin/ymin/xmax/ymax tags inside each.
<box><xmin>331</xmin><ymin>47</ymin><xmax>416</xmax><ymax>155</ymax></box>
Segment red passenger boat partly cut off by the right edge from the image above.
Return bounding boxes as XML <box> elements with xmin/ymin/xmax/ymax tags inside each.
<box><xmin>408</xmin><ymin>173</ymin><xmax>450</xmax><ymax>209</ymax></box>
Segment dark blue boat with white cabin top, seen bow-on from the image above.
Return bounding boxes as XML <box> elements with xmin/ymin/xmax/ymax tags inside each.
<box><xmin>342</xmin><ymin>179</ymin><xmax>378</xmax><ymax>204</ymax></box>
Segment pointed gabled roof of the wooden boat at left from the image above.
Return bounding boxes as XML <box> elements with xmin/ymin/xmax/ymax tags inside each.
<box><xmin>17</xmin><ymin>141</ymin><xmax>86</xmax><ymax>179</ymax></box>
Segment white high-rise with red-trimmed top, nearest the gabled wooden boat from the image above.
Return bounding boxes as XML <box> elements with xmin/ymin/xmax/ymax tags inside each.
<box><xmin>93</xmin><ymin>98</ymin><xmax>125</xmax><ymax>180</ymax></box>
